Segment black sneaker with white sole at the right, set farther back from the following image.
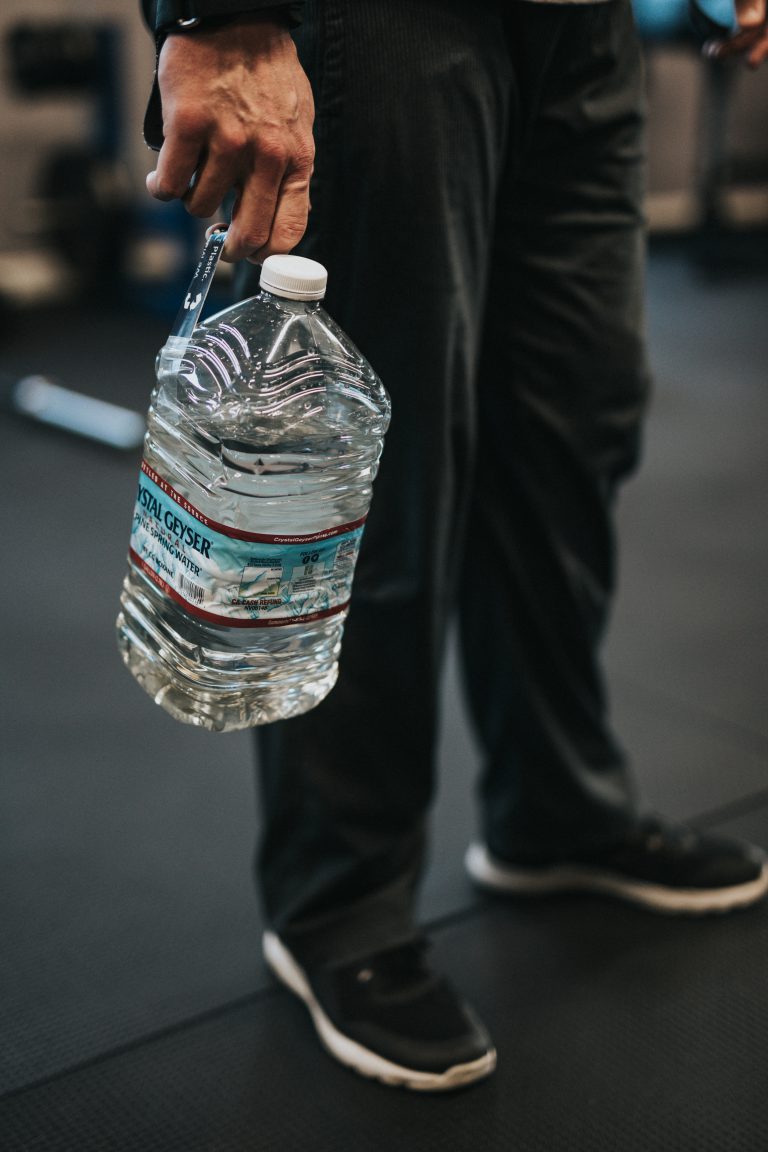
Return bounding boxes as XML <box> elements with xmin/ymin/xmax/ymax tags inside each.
<box><xmin>465</xmin><ymin>817</ymin><xmax>768</xmax><ymax>914</ymax></box>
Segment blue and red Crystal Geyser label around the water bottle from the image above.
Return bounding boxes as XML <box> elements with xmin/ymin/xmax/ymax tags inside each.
<box><xmin>130</xmin><ymin>461</ymin><xmax>365</xmax><ymax>628</ymax></box>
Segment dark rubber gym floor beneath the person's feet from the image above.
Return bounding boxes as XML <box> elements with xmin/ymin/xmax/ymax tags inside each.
<box><xmin>0</xmin><ymin>238</ymin><xmax>768</xmax><ymax>1152</ymax></box>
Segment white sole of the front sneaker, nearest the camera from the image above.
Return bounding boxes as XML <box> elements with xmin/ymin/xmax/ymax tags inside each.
<box><xmin>263</xmin><ymin>932</ymin><xmax>496</xmax><ymax>1092</ymax></box>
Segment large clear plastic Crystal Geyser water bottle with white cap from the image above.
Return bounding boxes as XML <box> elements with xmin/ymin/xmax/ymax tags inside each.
<box><xmin>117</xmin><ymin>253</ymin><xmax>389</xmax><ymax>732</ymax></box>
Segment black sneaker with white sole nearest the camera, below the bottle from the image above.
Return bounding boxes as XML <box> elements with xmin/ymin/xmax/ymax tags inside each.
<box><xmin>264</xmin><ymin>932</ymin><xmax>496</xmax><ymax>1092</ymax></box>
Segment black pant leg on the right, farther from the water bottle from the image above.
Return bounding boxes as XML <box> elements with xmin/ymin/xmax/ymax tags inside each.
<box><xmin>459</xmin><ymin>0</ymin><xmax>647</xmax><ymax>857</ymax></box>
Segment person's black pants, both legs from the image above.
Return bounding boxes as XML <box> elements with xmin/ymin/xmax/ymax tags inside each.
<box><xmin>237</xmin><ymin>0</ymin><xmax>647</xmax><ymax>962</ymax></box>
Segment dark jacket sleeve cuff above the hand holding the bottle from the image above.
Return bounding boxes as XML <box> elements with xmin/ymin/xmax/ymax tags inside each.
<box><xmin>140</xmin><ymin>0</ymin><xmax>304</xmax><ymax>151</ymax></box>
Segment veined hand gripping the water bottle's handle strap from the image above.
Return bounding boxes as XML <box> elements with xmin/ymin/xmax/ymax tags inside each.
<box><xmin>146</xmin><ymin>16</ymin><xmax>314</xmax><ymax>263</ymax></box>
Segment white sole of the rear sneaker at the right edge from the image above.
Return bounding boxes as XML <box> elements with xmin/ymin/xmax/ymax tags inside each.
<box><xmin>464</xmin><ymin>843</ymin><xmax>768</xmax><ymax>915</ymax></box>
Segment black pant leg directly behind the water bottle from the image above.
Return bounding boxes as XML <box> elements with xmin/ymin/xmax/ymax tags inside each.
<box><xmin>242</xmin><ymin>0</ymin><xmax>511</xmax><ymax>958</ymax></box>
